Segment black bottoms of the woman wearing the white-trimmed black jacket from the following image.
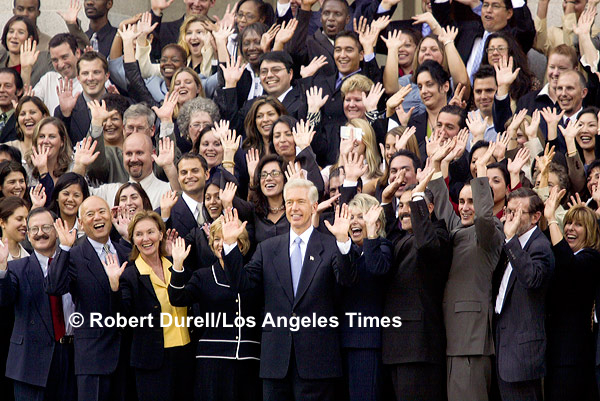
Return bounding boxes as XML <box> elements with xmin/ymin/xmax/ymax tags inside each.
<box><xmin>194</xmin><ymin>358</ymin><xmax>262</xmax><ymax>401</ymax></box>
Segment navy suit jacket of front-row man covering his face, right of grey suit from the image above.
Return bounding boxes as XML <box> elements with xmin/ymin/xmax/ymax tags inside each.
<box><xmin>494</xmin><ymin>228</ymin><xmax>554</xmax><ymax>382</ymax></box>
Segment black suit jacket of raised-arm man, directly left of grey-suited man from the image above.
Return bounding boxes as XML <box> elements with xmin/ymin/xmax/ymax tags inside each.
<box><xmin>381</xmin><ymin>200</ymin><xmax>450</xmax><ymax>364</ymax></box>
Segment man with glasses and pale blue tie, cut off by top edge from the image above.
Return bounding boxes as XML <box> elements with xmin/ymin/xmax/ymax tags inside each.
<box><xmin>432</xmin><ymin>0</ymin><xmax>535</xmax><ymax>83</ymax></box>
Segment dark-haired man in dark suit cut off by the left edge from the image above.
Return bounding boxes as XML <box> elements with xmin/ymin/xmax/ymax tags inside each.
<box><xmin>0</xmin><ymin>68</ymin><xmax>23</xmax><ymax>143</ymax></box>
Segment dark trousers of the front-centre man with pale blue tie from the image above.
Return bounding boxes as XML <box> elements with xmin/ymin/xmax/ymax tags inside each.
<box><xmin>263</xmin><ymin>347</ymin><xmax>340</xmax><ymax>401</ymax></box>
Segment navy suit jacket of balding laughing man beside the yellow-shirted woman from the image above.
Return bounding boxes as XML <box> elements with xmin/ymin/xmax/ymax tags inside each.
<box><xmin>46</xmin><ymin>238</ymin><xmax>129</xmax><ymax>375</ymax></box>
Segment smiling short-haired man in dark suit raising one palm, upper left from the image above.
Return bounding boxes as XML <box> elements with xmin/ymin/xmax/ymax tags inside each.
<box><xmin>54</xmin><ymin>52</ymin><xmax>109</xmax><ymax>145</ymax></box>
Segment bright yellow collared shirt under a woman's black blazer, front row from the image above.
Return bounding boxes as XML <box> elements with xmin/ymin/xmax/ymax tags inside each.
<box><xmin>135</xmin><ymin>256</ymin><xmax>190</xmax><ymax>348</ymax></box>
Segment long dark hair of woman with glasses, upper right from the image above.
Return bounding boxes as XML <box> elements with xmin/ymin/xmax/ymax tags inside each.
<box><xmin>481</xmin><ymin>32</ymin><xmax>536</xmax><ymax>100</ymax></box>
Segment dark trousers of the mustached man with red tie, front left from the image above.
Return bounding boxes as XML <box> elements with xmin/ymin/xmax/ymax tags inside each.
<box><xmin>14</xmin><ymin>343</ymin><xmax>77</xmax><ymax>401</ymax></box>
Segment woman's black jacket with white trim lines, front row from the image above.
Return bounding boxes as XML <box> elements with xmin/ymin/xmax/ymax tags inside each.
<box><xmin>169</xmin><ymin>263</ymin><xmax>263</xmax><ymax>360</ymax></box>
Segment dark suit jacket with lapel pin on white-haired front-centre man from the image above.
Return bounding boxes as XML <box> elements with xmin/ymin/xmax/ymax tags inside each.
<box><xmin>223</xmin><ymin>230</ymin><xmax>356</xmax><ymax>379</ymax></box>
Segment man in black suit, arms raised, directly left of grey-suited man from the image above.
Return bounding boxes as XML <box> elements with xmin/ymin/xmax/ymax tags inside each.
<box><xmin>381</xmin><ymin>171</ymin><xmax>451</xmax><ymax>400</ymax></box>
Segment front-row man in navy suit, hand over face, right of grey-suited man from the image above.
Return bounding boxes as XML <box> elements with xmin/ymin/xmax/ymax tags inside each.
<box><xmin>494</xmin><ymin>188</ymin><xmax>554</xmax><ymax>401</ymax></box>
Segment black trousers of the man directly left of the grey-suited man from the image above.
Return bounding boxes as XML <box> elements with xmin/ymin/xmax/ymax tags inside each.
<box><xmin>390</xmin><ymin>362</ymin><xmax>446</xmax><ymax>401</ymax></box>
